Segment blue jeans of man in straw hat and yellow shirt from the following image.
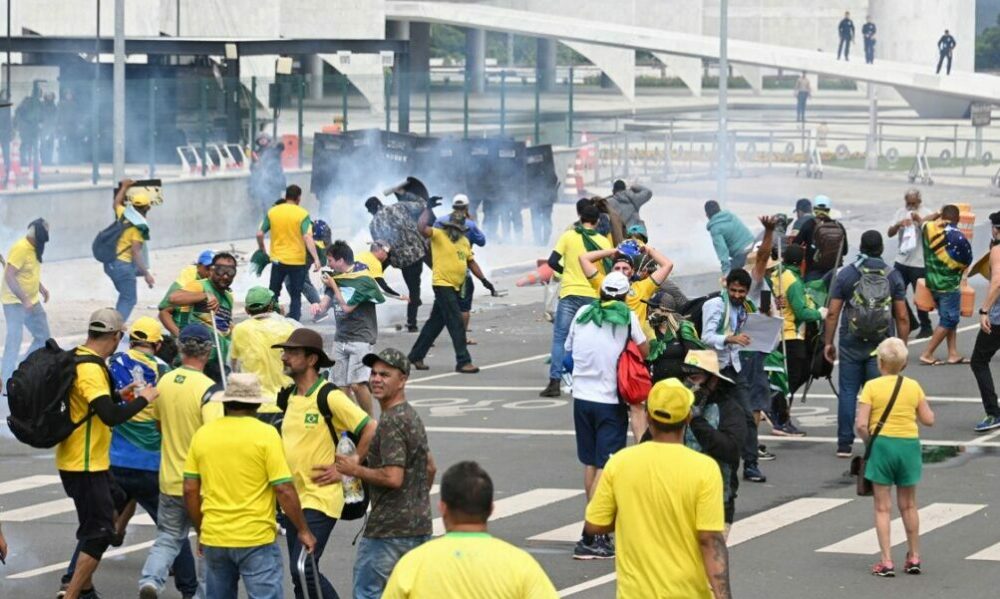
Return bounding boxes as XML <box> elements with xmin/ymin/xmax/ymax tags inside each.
<box><xmin>204</xmin><ymin>542</ymin><xmax>285</xmax><ymax>599</ymax></box>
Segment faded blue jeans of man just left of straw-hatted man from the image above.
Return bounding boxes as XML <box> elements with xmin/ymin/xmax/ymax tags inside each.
<box><xmin>139</xmin><ymin>493</ymin><xmax>205</xmax><ymax>597</ymax></box>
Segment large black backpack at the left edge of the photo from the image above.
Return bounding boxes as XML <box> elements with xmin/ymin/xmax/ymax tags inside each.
<box><xmin>7</xmin><ymin>339</ymin><xmax>111</xmax><ymax>449</ymax></box>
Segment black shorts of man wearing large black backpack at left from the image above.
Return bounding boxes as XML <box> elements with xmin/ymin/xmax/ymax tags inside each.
<box><xmin>59</xmin><ymin>470</ymin><xmax>125</xmax><ymax>552</ymax></box>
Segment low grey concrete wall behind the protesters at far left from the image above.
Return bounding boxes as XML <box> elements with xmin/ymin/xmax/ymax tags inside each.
<box><xmin>0</xmin><ymin>171</ymin><xmax>310</xmax><ymax>260</ymax></box>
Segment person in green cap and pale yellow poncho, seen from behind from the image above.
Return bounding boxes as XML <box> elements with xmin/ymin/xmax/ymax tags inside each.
<box><xmin>229</xmin><ymin>286</ymin><xmax>302</xmax><ymax>423</ymax></box>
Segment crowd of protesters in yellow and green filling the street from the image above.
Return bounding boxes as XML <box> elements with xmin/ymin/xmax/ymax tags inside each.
<box><xmin>0</xmin><ymin>171</ymin><xmax>1000</xmax><ymax>599</ymax></box>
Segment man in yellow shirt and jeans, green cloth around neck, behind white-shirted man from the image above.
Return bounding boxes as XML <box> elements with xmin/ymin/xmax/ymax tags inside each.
<box><xmin>539</xmin><ymin>202</ymin><xmax>611</xmax><ymax>397</ymax></box>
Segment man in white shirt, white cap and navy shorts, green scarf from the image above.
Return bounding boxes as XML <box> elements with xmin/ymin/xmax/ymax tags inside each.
<box><xmin>566</xmin><ymin>272</ymin><xmax>649</xmax><ymax>559</ymax></box>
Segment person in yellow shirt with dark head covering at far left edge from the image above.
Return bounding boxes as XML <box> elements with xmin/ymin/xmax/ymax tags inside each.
<box><xmin>0</xmin><ymin>218</ymin><xmax>51</xmax><ymax>390</ymax></box>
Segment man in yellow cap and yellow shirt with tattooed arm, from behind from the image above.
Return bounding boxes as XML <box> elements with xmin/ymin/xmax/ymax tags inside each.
<box><xmin>584</xmin><ymin>379</ymin><xmax>732</xmax><ymax>599</ymax></box>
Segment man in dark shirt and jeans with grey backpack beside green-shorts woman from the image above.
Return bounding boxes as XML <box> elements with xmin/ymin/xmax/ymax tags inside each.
<box><xmin>823</xmin><ymin>231</ymin><xmax>910</xmax><ymax>458</ymax></box>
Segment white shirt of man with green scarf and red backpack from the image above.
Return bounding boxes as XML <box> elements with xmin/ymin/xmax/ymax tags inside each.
<box><xmin>566</xmin><ymin>305</ymin><xmax>646</xmax><ymax>404</ymax></box>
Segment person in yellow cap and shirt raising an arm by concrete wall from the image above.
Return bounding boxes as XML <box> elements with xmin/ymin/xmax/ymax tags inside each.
<box><xmin>104</xmin><ymin>179</ymin><xmax>156</xmax><ymax>320</ymax></box>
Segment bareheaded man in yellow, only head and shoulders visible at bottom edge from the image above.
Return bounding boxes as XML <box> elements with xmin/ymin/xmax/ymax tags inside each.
<box><xmin>382</xmin><ymin>462</ymin><xmax>558</xmax><ymax>599</ymax></box>
